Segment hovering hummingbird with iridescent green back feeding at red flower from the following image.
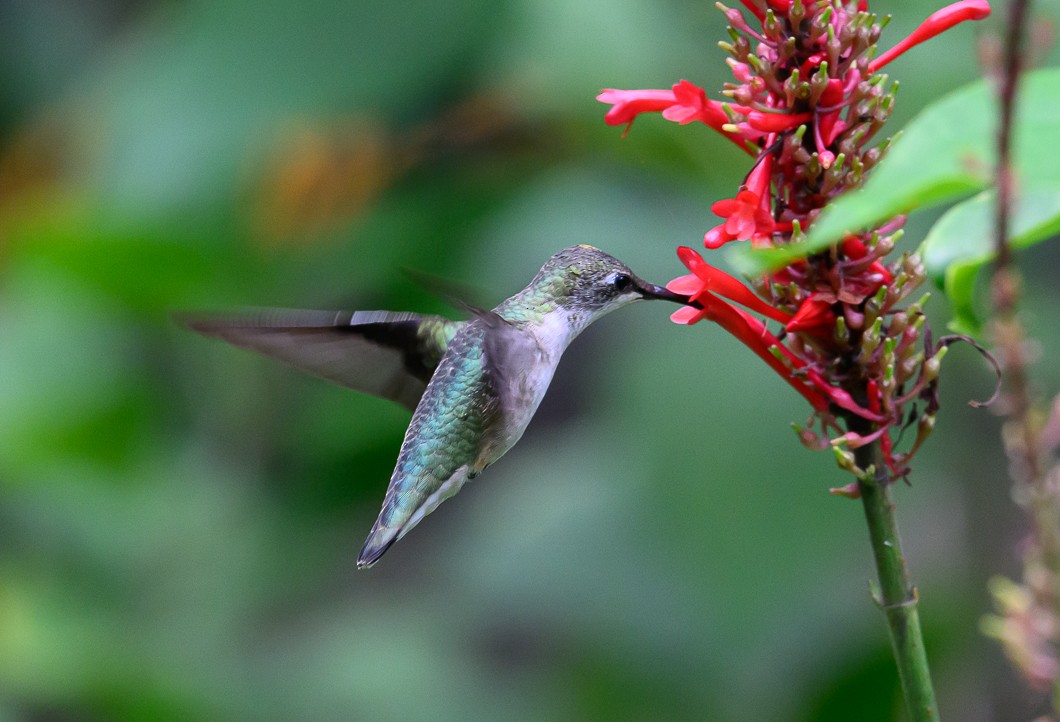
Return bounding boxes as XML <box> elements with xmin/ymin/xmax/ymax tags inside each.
<box><xmin>182</xmin><ymin>245</ymin><xmax>689</xmax><ymax>568</ymax></box>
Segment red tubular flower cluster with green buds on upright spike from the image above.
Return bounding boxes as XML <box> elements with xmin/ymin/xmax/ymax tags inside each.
<box><xmin>597</xmin><ymin>0</ymin><xmax>990</xmax><ymax>476</ymax></box>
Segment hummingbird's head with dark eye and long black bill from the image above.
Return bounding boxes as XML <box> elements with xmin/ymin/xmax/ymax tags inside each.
<box><xmin>531</xmin><ymin>245</ymin><xmax>689</xmax><ymax>322</ymax></box>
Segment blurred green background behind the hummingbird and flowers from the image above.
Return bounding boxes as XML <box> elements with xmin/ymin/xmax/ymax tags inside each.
<box><xmin>0</xmin><ymin>0</ymin><xmax>1060</xmax><ymax>721</ymax></box>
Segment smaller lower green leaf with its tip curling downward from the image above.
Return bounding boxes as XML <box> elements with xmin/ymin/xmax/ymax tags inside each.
<box><xmin>920</xmin><ymin>182</ymin><xmax>1060</xmax><ymax>336</ymax></box>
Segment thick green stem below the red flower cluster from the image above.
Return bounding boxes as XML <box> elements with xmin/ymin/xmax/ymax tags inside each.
<box><xmin>854</xmin><ymin>436</ymin><xmax>939</xmax><ymax>722</ymax></box>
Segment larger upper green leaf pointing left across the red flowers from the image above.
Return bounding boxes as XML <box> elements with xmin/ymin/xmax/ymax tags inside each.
<box><xmin>732</xmin><ymin>69</ymin><xmax>1060</xmax><ymax>274</ymax></box>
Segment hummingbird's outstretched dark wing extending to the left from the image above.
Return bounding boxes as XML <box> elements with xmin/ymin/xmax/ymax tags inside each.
<box><xmin>178</xmin><ymin>309</ymin><xmax>466</xmax><ymax>409</ymax></box>
